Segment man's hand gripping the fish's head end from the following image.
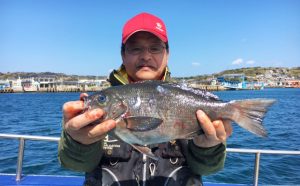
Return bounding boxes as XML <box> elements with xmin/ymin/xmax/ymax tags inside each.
<box><xmin>63</xmin><ymin>93</ymin><xmax>116</xmax><ymax>145</ymax></box>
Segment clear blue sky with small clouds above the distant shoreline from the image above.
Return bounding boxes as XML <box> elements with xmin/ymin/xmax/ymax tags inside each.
<box><xmin>0</xmin><ymin>0</ymin><xmax>300</xmax><ymax>77</ymax></box>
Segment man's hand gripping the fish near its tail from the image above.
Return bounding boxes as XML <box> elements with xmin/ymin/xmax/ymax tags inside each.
<box><xmin>194</xmin><ymin>110</ymin><xmax>232</xmax><ymax>148</ymax></box>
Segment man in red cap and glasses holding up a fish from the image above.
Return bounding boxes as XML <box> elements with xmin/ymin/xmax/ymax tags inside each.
<box><xmin>59</xmin><ymin>13</ymin><xmax>232</xmax><ymax>185</ymax></box>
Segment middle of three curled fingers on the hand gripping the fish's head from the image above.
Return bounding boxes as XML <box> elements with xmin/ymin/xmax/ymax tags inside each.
<box><xmin>65</xmin><ymin>109</ymin><xmax>104</xmax><ymax>130</ymax></box>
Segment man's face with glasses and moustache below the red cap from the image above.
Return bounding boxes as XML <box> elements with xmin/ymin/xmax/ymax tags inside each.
<box><xmin>122</xmin><ymin>32</ymin><xmax>169</xmax><ymax>81</ymax></box>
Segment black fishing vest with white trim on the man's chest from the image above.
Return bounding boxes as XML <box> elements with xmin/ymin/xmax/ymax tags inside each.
<box><xmin>84</xmin><ymin>137</ymin><xmax>202</xmax><ymax>186</ymax></box>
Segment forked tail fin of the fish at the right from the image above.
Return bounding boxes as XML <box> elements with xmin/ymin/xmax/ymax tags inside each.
<box><xmin>229</xmin><ymin>99</ymin><xmax>276</xmax><ymax>137</ymax></box>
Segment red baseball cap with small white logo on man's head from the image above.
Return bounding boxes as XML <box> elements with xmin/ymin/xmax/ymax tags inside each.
<box><xmin>122</xmin><ymin>13</ymin><xmax>168</xmax><ymax>44</ymax></box>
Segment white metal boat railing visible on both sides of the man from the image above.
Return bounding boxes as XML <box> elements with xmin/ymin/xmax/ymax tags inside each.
<box><xmin>0</xmin><ymin>133</ymin><xmax>300</xmax><ymax>186</ymax></box>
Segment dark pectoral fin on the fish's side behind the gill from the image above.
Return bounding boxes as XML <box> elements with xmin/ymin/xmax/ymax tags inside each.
<box><xmin>124</xmin><ymin>116</ymin><xmax>163</xmax><ymax>132</ymax></box>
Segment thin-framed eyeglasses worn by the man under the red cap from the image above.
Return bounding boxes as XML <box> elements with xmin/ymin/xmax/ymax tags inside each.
<box><xmin>125</xmin><ymin>45</ymin><xmax>166</xmax><ymax>55</ymax></box>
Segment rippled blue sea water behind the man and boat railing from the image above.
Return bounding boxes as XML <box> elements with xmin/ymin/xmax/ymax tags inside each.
<box><xmin>0</xmin><ymin>89</ymin><xmax>300</xmax><ymax>185</ymax></box>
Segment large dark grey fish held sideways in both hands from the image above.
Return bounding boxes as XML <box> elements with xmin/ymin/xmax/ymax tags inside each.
<box><xmin>85</xmin><ymin>81</ymin><xmax>275</xmax><ymax>156</ymax></box>
